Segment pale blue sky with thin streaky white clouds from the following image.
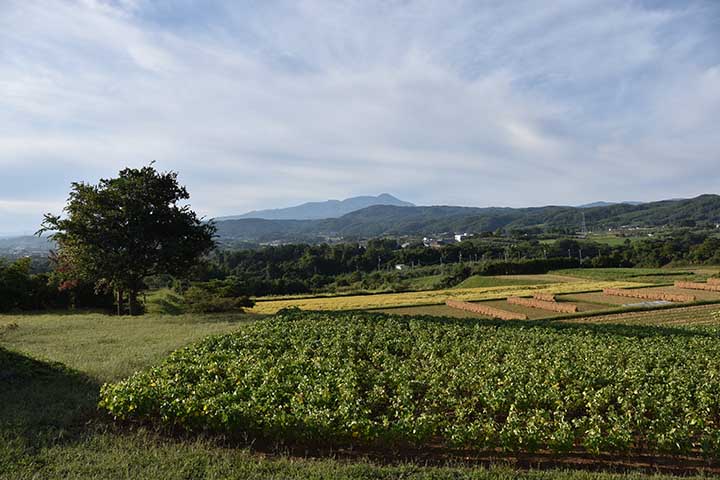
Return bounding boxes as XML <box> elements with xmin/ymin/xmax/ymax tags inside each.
<box><xmin>0</xmin><ymin>0</ymin><xmax>720</xmax><ymax>234</ymax></box>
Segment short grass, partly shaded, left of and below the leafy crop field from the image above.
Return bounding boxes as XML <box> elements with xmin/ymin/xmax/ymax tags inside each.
<box><xmin>0</xmin><ymin>314</ymin><xmax>716</xmax><ymax>480</ymax></box>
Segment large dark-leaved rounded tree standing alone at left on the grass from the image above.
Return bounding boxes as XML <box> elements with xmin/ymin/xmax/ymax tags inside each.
<box><xmin>38</xmin><ymin>164</ymin><xmax>215</xmax><ymax>315</ymax></box>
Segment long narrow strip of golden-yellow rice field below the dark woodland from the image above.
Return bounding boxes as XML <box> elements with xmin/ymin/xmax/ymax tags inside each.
<box><xmin>249</xmin><ymin>281</ymin><xmax>650</xmax><ymax>314</ymax></box>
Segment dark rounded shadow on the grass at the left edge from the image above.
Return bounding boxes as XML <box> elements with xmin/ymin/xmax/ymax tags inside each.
<box><xmin>0</xmin><ymin>348</ymin><xmax>100</xmax><ymax>448</ymax></box>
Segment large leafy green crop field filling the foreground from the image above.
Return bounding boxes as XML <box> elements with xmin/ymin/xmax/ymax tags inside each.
<box><xmin>101</xmin><ymin>311</ymin><xmax>720</xmax><ymax>461</ymax></box>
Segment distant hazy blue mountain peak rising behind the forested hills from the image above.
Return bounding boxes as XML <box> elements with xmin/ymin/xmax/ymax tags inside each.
<box><xmin>215</xmin><ymin>193</ymin><xmax>414</xmax><ymax>221</ymax></box>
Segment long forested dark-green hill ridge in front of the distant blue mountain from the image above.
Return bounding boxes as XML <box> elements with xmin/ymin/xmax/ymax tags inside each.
<box><xmin>217</xmin><ymin>195</ymin><xmax>720</xmax><ymax>241</ymax></box>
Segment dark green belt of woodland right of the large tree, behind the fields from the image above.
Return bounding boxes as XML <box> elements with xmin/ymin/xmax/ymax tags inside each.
<box><xmin>187</xmin><ymin>230</ymin><xmax>720</xmax><ymax>296</ymax></box>
